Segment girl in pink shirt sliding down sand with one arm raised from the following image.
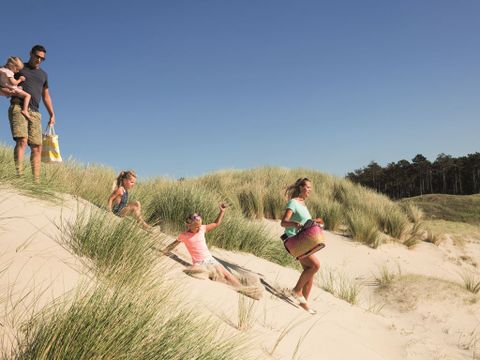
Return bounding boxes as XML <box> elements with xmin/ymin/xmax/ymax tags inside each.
<box><xmin>163</xmin><ymin>203</ymin><xmax>242</xmax><ymax>287</ymax></box>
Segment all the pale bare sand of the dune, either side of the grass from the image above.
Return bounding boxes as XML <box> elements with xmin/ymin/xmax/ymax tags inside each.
<box><xmin>0</xmin><ymin>188</ymin><xmax>480</xmax><ymax>359</ymax></box>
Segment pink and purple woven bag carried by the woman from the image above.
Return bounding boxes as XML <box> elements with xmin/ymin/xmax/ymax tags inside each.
<box><xmin>283</xmin><ymin>221</ymin><xmax>325</xmax><ymax>260</ymax></box>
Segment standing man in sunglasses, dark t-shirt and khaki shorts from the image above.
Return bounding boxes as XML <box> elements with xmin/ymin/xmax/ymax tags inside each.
<box><xmin>8</xmin><ymin>45</ymin><xmax>55</xmax><ymax>182</ymax></box>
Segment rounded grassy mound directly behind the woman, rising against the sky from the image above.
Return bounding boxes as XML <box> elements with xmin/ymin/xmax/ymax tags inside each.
<box><xmin>192</xmin><ymin>167</ymin><xmax>420</xmax><ymax>247</ymax></box>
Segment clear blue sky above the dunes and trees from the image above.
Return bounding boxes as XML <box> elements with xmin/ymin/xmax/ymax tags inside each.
<box><xmin>0</xmin><ymin>0</ymin><xmax>480</xmax><ymax>178</ymax></box>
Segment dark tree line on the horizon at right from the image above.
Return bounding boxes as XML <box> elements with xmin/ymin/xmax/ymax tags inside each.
<box><xmin>346</xmin><ymin>152</ymin><xmax>480</xmax><ymax>199</ymax></box>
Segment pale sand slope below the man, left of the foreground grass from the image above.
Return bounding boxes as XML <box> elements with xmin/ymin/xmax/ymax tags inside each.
<box><xmin>0</xmin><ymin>188</ymin><xmax>92</xmax><ymax>347</ymax></box>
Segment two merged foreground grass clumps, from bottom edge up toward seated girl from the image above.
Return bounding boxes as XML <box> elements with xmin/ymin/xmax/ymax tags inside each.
<box><xmin>5</xmin><ymin>188</ymin><xmax>246</xmax><ymax>360</ymax></box>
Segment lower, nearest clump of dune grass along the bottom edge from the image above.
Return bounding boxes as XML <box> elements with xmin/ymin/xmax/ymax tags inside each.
<box><xmin>9</xmin><ymin>283</ymin><xmax>245</xmax><ymax>360</ymax></box>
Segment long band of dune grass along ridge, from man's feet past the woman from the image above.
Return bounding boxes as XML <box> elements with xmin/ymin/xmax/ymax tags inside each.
<box><xmin>0</xmin><ymin>146</ymin><xmax>424</xmax><ymax>256</ymax></box>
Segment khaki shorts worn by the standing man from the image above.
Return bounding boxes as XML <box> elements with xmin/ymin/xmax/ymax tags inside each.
<box><xmin>8</xmin><ymin>105</ymin><xmax>42</xmax><ymax>145</ymax></box>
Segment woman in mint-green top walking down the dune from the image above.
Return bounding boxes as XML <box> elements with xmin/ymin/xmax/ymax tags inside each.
<box><xmin>281</xmin><ymin>178</ymin><xmax>323</xmax><ymax>315</ymax></box>
